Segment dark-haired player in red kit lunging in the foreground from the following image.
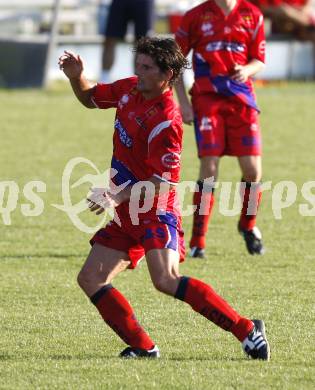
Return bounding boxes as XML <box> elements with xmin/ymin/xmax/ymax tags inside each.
<box><xmin>59</xmin><ymin>38</ymin><xmax>269</xmax><ymax>360</ymax></box>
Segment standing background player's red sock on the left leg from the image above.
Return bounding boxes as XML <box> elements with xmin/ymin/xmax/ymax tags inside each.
<box><xmin>189</xmin><ymin>180</ymin><xmax>214</xmax><ymax>248</ymax></box>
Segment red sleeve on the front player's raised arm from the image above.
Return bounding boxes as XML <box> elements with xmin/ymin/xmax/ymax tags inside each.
<box><xmin>91</xmin><ymin>77</ymin><xmax>136</xmax><ymax>108</ymax></box>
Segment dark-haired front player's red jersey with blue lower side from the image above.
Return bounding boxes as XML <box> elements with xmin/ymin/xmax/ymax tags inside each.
<box><xmin>92</xmin><ymin>77</ymin><xmax>183</xmax><ymax>218</ymax></box>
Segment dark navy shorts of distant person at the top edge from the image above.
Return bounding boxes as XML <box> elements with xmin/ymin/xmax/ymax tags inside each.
<box><xmin>105</xmin><ymin>0</ymin><xmax>154</xmax><ymax>39</ymax></box>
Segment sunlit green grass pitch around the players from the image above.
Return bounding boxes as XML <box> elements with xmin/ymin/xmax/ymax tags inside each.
<box><xmin>0</xmin><ymin>84</ymin><xmax>315</xmax><ymax>389</ymax></box>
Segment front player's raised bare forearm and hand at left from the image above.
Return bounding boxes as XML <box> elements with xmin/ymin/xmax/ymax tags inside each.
<box><xmin>58</xmin><ymin>51</ymin><xmax>95</xmax><ymax>108</ymax></box>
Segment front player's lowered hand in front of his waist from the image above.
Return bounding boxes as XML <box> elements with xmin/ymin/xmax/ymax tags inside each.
<box><xmin>87</xmin><ymin>188</ymin><xmax>121</xmax><ymax>215</ymax></box>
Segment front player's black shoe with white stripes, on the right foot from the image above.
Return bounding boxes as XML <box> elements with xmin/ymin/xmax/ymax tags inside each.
<box><xmin>242</xmin><ymin>320</ymin><xmax>270</xmax><ymax>360</ymax></box>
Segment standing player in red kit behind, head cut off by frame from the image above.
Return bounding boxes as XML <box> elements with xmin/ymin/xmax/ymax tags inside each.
<box><xmin>176</xmin><ymin>0</ymin><xmax>265</xmax><ymax>257</ymax></box>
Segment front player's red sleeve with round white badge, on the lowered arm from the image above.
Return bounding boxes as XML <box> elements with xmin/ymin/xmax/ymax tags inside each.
<box><xmin>147</xmin><ymin>120</ymin><xmax>182</xmax><ymax>185</ymax></box>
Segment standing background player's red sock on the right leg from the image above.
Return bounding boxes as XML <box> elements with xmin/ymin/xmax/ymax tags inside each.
<box><xmin>239</xmin><ymin>179</ymin><xmax>262</xmax><ymax>230</ymax></box>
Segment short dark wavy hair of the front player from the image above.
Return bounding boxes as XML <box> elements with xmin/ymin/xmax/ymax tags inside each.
<box><xmin>134</xmin><ymin>37</ymin><xmax>189</xmax><ymax>85</ymax></box>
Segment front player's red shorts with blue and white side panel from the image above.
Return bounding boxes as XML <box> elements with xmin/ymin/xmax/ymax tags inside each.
<box><xmin>90</xmin><ymin>213</ymin><xmax>185</xmax><ymax>269</ymax></box>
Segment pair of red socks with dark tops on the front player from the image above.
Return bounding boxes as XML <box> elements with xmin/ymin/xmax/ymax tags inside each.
<box><xmin>91</xmin><ymin>276</ymin><xmax>254</xmax><ymax>350</ymax></box>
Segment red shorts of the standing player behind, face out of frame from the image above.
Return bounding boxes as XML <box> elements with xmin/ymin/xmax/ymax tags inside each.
<box><xmin>192</xmin><ymin>95</ymin><xmax>261</xmax><ymax>157</ymax></box>
